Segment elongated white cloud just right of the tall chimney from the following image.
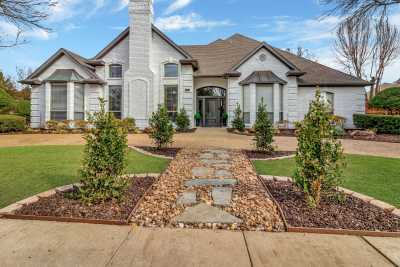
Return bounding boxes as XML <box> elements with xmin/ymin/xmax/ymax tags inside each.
<box><xmin>155</xmin><ymin>13</ymin><xmax>233</xmax><ymax>31</ymax></box>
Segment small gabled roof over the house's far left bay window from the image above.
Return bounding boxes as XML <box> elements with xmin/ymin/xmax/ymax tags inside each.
<box><xmin>20</xmin><ymin>48</ymin><xmax>104</xmax><ymax>84</ymax></box>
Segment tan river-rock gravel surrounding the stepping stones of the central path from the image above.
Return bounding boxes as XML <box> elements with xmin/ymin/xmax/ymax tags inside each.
<box><xmin>131</xmin><ymin>149</ymin><xmax>284</xmax><ymax>231</ymax></box>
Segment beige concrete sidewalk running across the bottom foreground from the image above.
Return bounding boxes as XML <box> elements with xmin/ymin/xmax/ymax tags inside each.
<box><xmin>0</xmin><ymin>219</ymin><xmax>400</xmax><ymax>267</ymax></box>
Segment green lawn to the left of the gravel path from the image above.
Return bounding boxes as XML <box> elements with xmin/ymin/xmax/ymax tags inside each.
<box><xmin>0</xmin><ymin>146</ymin><xmax>168</xmax><ymax>208</ymax></box>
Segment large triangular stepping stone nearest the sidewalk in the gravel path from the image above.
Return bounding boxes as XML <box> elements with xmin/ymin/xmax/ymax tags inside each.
<box><xmin>172</xmin><ymin>203</ymin><xmax>242</xmax><ymax>224</ymax></box>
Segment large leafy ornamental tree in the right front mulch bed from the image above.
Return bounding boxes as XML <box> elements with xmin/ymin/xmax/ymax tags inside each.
<box><xmin>294</xmin><ymin>89</ymin><xmax>344</xmax><ymax>207</ymax></box>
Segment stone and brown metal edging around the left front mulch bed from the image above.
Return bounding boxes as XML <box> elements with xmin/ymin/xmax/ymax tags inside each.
<box><xmin>0</xmin><ymin>173</ymin><xmax>161</xmax><ymax>225</ymax></box>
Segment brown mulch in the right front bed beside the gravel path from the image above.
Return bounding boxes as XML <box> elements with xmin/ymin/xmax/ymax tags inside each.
<box><xmin>265</xmin><ymin>181</ymin><xmax>400</xmax><ymax>232</ymax></box>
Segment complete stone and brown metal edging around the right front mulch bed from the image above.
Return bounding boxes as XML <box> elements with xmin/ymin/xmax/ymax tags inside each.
<box><xmin>258</xmin><ymin>175</ymin><xmax>400</xmax><ymax>238</ymax></box>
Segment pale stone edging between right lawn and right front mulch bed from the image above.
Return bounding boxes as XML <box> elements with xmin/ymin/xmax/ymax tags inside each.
<box><xmin>260</xmin><ymin>175</ymin><xmax>400</xmax><ymax>217</ymax></box>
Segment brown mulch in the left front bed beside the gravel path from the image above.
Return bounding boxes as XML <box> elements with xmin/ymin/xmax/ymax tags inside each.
<box><xmin>16</xmin><ymin>177</ymin><xmax>156</xmax><ymax>221</ymax></box>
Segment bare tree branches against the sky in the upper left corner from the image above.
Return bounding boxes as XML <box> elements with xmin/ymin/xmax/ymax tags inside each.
<box><xmin>0</xmin><ymin>0</ymin><xmax>56</xmax><ymax>48</ymax></box>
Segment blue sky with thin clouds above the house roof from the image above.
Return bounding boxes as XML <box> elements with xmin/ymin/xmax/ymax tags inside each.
<box><xmin>0</xmin><ymin>0</ymin><xmax>400</xmax><ymax>81</ymax></box>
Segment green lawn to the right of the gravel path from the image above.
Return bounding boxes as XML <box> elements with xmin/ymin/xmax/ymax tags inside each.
<box><xmin>254</xmin><ymin>155</ymin><xmax>400</xmax><ymax>208</ymax></box>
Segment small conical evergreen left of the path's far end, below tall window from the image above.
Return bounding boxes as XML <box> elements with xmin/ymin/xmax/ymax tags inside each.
<box><xmin>149</xmin><ymin>106</ymin><xmax>174</xmax><ymax>149</ymax></box>
